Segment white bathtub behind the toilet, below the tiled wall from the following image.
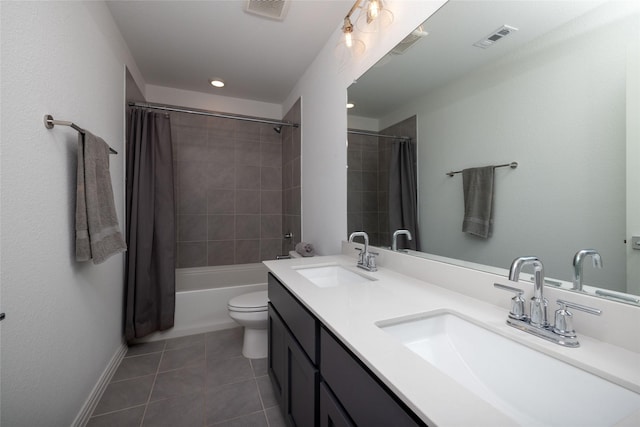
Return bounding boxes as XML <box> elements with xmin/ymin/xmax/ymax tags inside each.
<box><xmin>141</xmin><ymin>263</ymin><xmax>267</xmax><ymax>341</ymax></box>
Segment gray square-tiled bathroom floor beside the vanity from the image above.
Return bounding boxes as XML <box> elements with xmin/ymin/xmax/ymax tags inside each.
<box><xmin>87</xmin><ymin>328</ymin><xmax>285</xmax><ymax>427</ymax></box>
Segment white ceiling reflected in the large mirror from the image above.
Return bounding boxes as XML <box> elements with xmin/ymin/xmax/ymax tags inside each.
<box><xmin>349</xmin><ymin>0</ymin><xmax>603</xmax><ymax>119</ymax></box>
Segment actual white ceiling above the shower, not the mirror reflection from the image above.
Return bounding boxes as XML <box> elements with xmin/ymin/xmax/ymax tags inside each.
<box><xmin>107</xmin><ymin>0</ymin><xmax>353</xmax><ymax>104</ymax></box>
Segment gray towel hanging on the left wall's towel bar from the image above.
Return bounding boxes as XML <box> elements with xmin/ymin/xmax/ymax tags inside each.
<box><xmin>76</xmin><ymin>132</ymin><xmax>127</xmax><ymax>264</ymax></box>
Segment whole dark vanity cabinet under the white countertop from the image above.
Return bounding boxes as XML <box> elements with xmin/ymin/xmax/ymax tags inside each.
<box><xmin>268</xmin><ymin>273</ymin><xmax>425</xmax><ymax>427</ymax></box>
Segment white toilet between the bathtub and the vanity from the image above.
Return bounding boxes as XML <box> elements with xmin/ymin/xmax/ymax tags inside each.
<box><xmin>227</xmin><ymin>291</ymin><xmax>268</xmax><ymax>359</ymax></box>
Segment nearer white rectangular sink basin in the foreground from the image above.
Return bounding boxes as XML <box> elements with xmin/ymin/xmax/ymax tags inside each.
<box><xmin>376</xmin><ymin>312</ymin><xmax>640</xmax><ymax>426</ymax></box>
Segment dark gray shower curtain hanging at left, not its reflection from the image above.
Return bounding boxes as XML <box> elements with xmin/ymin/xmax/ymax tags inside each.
<box><xmin>125</xmin><ymin>108</ymin><xmax>175</xmax><ymax>341</ymax></box>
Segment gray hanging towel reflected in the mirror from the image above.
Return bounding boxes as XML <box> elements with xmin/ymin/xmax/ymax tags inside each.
<box><xmin>462</xmin><ymin>166</ymin><xmax>494</xmax><ymax>239</ymax></box>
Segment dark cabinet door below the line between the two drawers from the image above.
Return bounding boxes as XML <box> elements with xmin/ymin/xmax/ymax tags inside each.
<box><xmin>285</xmin><ymin>334</ymin><xmax>320</xmax><ymax>427</ymax></box>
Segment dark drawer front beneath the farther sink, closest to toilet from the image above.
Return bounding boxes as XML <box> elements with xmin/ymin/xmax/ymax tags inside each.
<box><xmin>268</xmin><ymin>273</ymin><xmax>319</xmax><ymax>365</ymax></box>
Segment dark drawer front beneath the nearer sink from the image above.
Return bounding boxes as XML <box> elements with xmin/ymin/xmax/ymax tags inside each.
<box><xmin>320</xmin><ymin>327</ymin><xmax>428</xmax><ymax>427</ymax></box>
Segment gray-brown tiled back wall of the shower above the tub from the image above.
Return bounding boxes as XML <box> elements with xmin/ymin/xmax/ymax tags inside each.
<box><xmin>171</xmin><ymin>113</ymin><xmax>284</xmax><ymax>268</ymax></box>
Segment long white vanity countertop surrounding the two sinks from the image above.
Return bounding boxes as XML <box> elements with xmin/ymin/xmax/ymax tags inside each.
<box><xmin>264</xmin><ymin>255</ymin><xmax>640</xmax><ymax>426</ymax></box>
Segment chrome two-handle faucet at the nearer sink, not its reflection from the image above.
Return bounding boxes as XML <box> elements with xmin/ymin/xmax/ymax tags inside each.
<box><xmin>493</xmin><ymin>257</ymin><xmax>601</xmax><ymax>347</ymax></box>
